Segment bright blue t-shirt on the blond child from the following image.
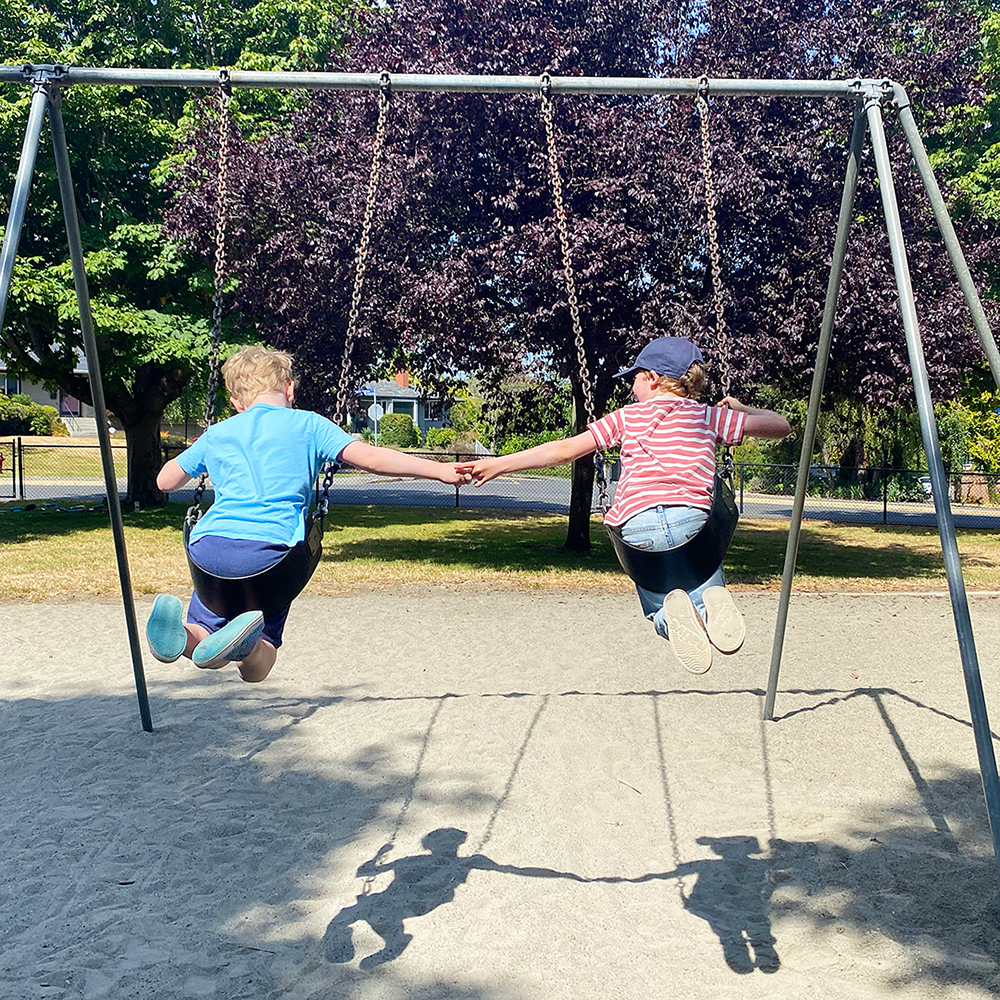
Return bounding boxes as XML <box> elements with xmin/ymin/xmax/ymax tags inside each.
<box><xmin>177</xmin><ymin>403</ymin><xmax>354</xmax><ymax>545</ymax></box>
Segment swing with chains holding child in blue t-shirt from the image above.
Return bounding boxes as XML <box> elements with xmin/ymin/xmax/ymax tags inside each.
<box><xmin>184</xmin><ymin>70</ymin><xmax>389</xmax><ymax>620</ymax></box>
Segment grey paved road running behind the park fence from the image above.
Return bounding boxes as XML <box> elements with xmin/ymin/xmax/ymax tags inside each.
<box><xmin>7</xmin><ymin>472</ymin><xmax>1000</xmax><ymax>529</ymax></box>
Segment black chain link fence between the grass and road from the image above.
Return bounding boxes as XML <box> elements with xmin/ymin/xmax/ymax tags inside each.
<box><xmin>0</xmin><ymin>438</ymin><xmax>1000</xmax><ymax>528</ymax></box>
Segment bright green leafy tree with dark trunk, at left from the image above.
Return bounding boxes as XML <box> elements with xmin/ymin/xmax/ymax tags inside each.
<box><xmin>0</xmin><ymin>0</ymin><xmax>352</xmax><ymax>504</ymax></box>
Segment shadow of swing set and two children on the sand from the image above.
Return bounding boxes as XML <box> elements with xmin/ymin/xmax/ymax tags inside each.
<box><xmin>320</xmin><ymin>688</ymin><xmax>989</xmax><ymax>975</ymax></box>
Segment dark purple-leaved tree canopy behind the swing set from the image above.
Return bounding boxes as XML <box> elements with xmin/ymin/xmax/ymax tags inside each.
<box><xmin>171</xmin><ymin>0</ymin><xmax>996</xmax><ymax>545</ymax></box>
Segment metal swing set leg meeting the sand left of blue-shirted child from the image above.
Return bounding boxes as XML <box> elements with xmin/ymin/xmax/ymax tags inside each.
<box><xmin>49</xmin><ymin>86</ymin><xmax>153</xmax><ymax>733</ymax></box>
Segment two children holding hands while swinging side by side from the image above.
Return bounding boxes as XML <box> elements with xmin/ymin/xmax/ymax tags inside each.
<box><xmin>146</xmin><ymin>337</ymin><xmax>791</xmax><ymax>682</ymax></box>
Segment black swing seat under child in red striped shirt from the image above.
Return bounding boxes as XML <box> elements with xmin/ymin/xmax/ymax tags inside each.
<box><xmin>605</xmin><ymin>473</ymin><xmax>740</xmax><ymax>594</ymax></box>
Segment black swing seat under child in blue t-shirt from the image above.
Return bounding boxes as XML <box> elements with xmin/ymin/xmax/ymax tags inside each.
<box><xmin>184</xmin><ymin>512</ymin><xmax>323</xmax><ymax>621</ymax></box>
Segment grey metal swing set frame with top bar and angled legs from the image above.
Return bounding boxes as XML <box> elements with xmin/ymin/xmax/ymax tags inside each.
<box><xmin>0</xmin><ymin>65</ymin><xmax>1000</xmax><ymax>874</ymax></box>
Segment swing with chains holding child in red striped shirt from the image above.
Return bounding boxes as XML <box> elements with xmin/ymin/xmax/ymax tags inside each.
<box><xmin>541</xmin><ymin>80</ymin><xmax>739</xmax><ymax>594</ymax></box>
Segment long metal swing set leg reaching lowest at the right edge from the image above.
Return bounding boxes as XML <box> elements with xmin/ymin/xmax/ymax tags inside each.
<box><xmin>865</xmin><ymin>92</ymin><xmax>1000</xmax><ymax>875</ymax></box>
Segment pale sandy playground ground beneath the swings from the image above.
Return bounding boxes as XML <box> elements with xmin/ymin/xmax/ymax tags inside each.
<box><xmin>0</xmin><ymin>590</ymin><xmax>1000</xmax><ymax>1000</ymax></box>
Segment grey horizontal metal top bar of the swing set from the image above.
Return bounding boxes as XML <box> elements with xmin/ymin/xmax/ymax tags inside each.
<box><xmin>0</xmin><ymin>66</ymin><xmax>893</xmax><ymax>97</ymax></box>
